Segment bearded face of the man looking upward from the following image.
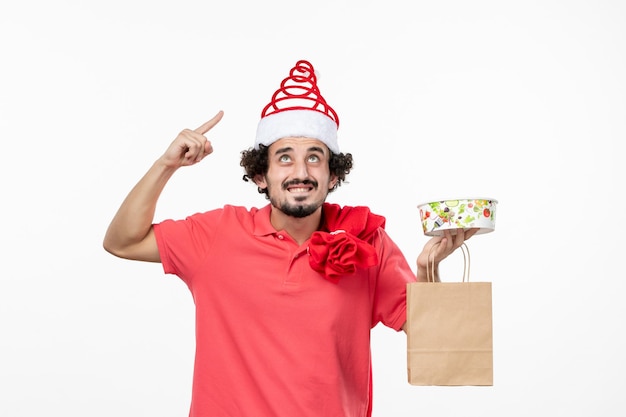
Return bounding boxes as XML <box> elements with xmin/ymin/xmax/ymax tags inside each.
<box><xmin>257</xmin><ymin>137</ymin><xmax>337</xmax><ymax>217</ymax></box>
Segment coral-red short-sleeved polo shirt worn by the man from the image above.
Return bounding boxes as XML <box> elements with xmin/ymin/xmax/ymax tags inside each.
<box><xmin>154</xmin><ymin>205</ymin><xmax>415</xmax><ymax>417</ymax></box>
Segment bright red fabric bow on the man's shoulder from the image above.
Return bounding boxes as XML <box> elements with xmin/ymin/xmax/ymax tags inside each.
<box><xmin>309</xmin><ymin>203</ymin><xmax>385</xmax><ymax>284</ymax></box>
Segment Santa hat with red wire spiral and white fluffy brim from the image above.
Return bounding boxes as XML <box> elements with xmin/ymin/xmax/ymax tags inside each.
<box><xmin>254</xmin><ymin>60</ymin><xmax>339</xmax><ymax>154</ymax></box>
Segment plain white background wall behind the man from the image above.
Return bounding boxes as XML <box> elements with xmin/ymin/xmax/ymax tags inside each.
<box><xmin>0</xmin><ymin>0</ymin><xmax>626</xmax><ymax>417</ymax></box>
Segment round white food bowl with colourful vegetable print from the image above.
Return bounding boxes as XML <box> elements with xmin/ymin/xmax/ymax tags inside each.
<box><xmin>417</xmin><ymin>198</ymin><xmax>498</xmax><ymax>236</ymax></box>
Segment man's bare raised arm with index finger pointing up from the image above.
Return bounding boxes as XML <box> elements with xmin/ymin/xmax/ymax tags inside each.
<box><xmin>103</xmin><ymin>111</ymin><xmax>223</xmax><ymax>262</ymax></box>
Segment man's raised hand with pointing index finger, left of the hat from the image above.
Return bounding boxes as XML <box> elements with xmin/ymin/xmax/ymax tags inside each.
<box><xmin>161</xmin><ymin>110</ymin><xmax>224</xmax><ymax>168</ymax></box>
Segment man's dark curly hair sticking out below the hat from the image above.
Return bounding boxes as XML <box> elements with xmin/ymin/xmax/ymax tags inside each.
<box><xmin>239</xmin><ymin>145</ymin><xmax>353</xmax><ymax>199</ymax></box>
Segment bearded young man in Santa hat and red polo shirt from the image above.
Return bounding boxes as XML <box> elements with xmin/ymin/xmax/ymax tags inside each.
<box><xmin>104</xmin><ymin>61</ymin><xmax>474</xmax><ymax>417</ymax></box>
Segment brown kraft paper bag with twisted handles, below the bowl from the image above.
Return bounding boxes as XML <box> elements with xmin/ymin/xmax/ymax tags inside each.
<box><xmin>406</xmin><ymin>244</ymin><xmax>493</xmax><ymax>386</ymax></box>
